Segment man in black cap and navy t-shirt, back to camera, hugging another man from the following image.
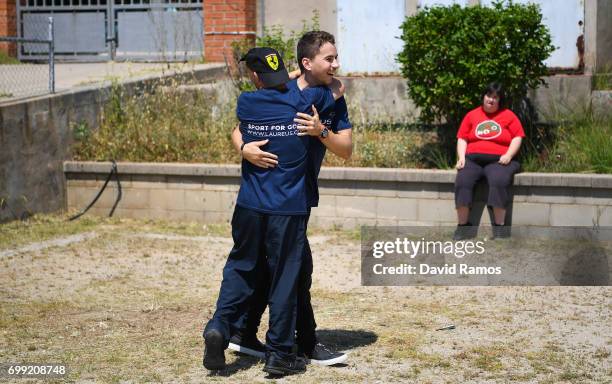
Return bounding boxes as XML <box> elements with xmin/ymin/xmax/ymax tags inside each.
<box><xmin>204</xmin><ymin>48</ymin><xmax>341</xmax><ymax>375</ymax></box>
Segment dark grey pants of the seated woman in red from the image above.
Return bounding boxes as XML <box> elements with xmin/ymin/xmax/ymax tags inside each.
<box><xmin>455</xmin><ymin>154</ymin><xmax>521</xmax><ymax>208</ymax></box>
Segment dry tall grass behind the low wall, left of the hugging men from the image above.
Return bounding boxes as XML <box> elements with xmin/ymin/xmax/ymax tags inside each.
<box><xmin>73</xmin><ymin>80</ymin><xmax>238</xmax><ymax>163</ymax></box>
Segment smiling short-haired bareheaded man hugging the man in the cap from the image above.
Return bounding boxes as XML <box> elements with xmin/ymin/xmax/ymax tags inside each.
<box><xmin>229</xmin><ymin>31</ymin><xmax>352</xmax><ymax>365</ymax></box>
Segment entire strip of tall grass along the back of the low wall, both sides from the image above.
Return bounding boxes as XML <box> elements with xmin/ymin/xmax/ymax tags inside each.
<box><xmin>74</xmin><ymin>84</ymin><xmax>612</xmax><ymax>173</ymax></box>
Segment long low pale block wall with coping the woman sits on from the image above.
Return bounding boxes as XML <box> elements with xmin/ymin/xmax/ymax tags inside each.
<box><xmin>64</xmin><ymin>162</ymin><xmax>612</xmax><ymax>228</ymax></box>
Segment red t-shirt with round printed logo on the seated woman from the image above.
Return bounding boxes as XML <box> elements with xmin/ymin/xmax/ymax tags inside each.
<box><xmin>457</xmin><ymin>106</ymin><xmax>525</xmax><ymax>155</ymax></box>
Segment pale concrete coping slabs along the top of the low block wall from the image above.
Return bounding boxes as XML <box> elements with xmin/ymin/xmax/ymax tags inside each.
<box><xmin>64</xmin><ymin>161</ymin><xmax>612</xmax><ymax>189</ymax></box>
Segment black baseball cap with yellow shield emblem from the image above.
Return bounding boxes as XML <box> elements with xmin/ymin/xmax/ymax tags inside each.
<box><xmin>240</xmin><ymin>47</ymin><xmax>289</xmax><ymax>88</ymax></box>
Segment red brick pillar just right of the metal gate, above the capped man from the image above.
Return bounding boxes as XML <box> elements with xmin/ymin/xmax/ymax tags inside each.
<box><xmin>203</xmin><ymin>0</ymin><xmax>257</xmax><ymax>62</ymax></box>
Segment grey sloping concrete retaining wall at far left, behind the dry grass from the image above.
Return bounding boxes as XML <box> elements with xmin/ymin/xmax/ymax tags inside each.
<box><xmin>0</xmin><ymin>65</ymin><xmax>225</xmax><ymax>222</ymax></box>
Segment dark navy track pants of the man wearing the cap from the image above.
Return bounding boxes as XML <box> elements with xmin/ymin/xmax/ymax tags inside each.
<box><xmin>204</xmin><ymin>206</ymin><xmax>306</xmax><ymax>357</ymax></box>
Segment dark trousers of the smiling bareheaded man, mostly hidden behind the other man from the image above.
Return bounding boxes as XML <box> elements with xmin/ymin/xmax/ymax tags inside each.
<box><xmin>242</xmin><ymin>216</ymin><xmax>317</xmax><ymax>351</ymax></box>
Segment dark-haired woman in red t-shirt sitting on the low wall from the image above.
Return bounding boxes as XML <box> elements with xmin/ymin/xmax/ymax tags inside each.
<box><xmin>454</xmin><ymin>83</ymin><xmax>525</xmax><ymax>240</ymax></box>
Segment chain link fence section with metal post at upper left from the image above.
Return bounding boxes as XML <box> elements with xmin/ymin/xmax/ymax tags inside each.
<box><xmin>0</xmin><ymin>17</ymin><xmax>55</xmax><ymax>102</ymax></box>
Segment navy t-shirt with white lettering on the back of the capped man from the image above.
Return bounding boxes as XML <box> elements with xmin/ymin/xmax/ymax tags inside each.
<box><xmin>236</xmin><ymin>86</ymin><xmax>334</xmax><ymax>215</ymax></box>
